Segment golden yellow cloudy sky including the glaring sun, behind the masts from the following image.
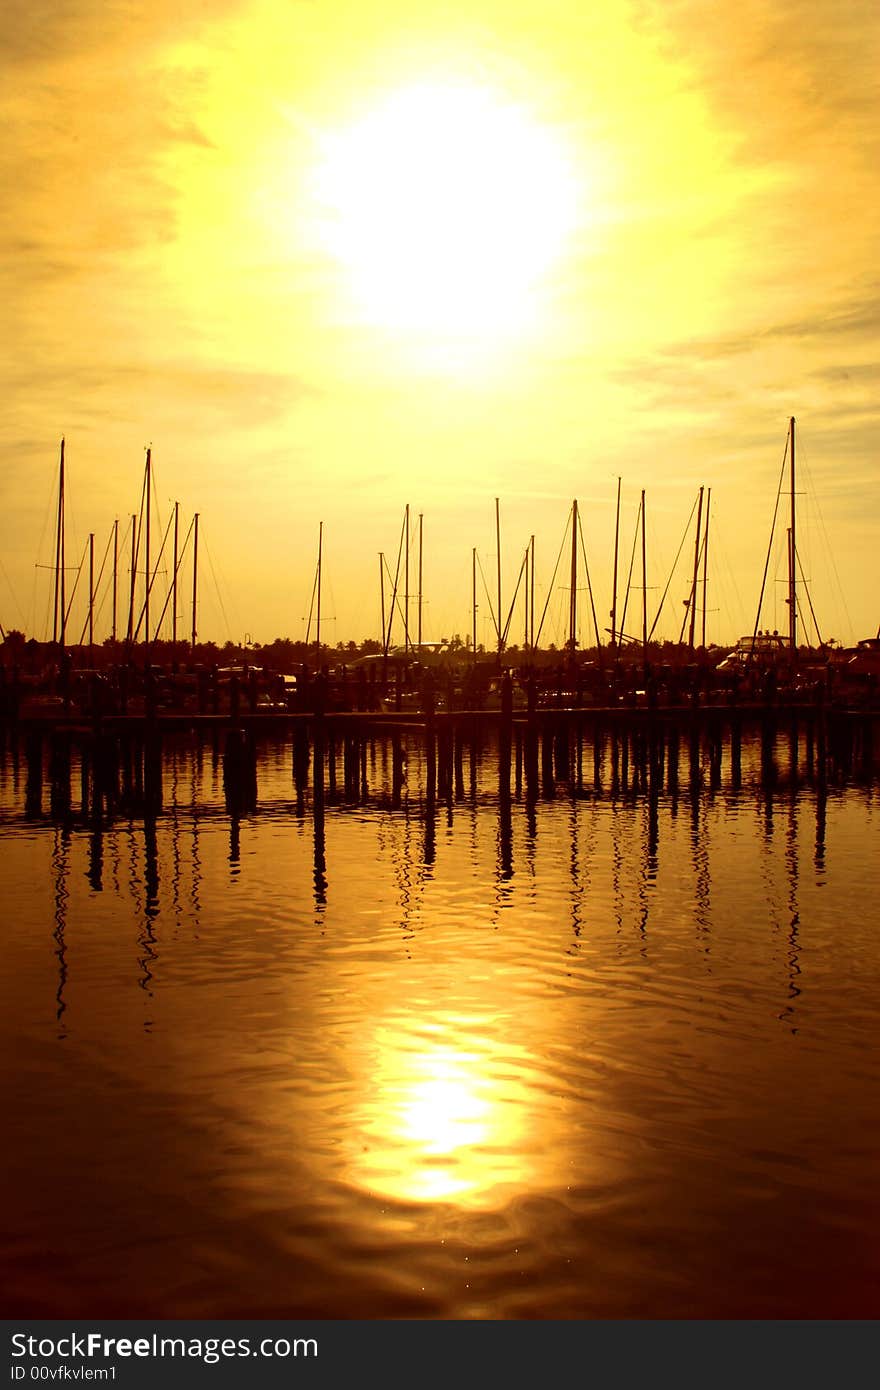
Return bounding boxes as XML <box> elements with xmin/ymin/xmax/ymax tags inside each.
<box><xmin>0</xmin><ymin>0</ymin><xmax>880</xmax><ymax>644</ymax></box>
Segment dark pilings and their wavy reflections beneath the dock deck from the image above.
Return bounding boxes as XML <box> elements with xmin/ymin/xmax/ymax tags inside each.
<box><xmin>4</xmin><ymin>720</ymin><xmax>873</xmax><ymax>931</ymax></box>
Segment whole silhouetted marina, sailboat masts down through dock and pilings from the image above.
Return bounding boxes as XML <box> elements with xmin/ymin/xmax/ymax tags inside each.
<box><xmin>0</xmin><ymin>418</ymin><xmax>880</xmax><ymax>867</ymax></box>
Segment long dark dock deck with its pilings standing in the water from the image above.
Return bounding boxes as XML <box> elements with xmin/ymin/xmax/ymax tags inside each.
<box><xmin>3</xmin><ymin>676</ymin><xmax>880</xmax><ymax>916</ymax></box>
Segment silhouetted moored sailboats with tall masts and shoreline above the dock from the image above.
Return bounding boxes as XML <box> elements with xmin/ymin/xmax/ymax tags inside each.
<box><xmin>10</xmin><ymin>417</ymin><xmax>880</xmax><ymax>717</ymax></box>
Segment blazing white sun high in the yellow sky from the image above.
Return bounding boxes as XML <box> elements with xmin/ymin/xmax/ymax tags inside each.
<box><xmin>312</xmin><ymin>82</ymin><xmax>578</xmax><ymax>350</ymax></box>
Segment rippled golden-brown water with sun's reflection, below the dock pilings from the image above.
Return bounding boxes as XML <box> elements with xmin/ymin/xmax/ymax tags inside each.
<box><xmin>0</xmin><ymin>738</ymin><xmax>880</xmax><ymax>1318</ymax></box>
